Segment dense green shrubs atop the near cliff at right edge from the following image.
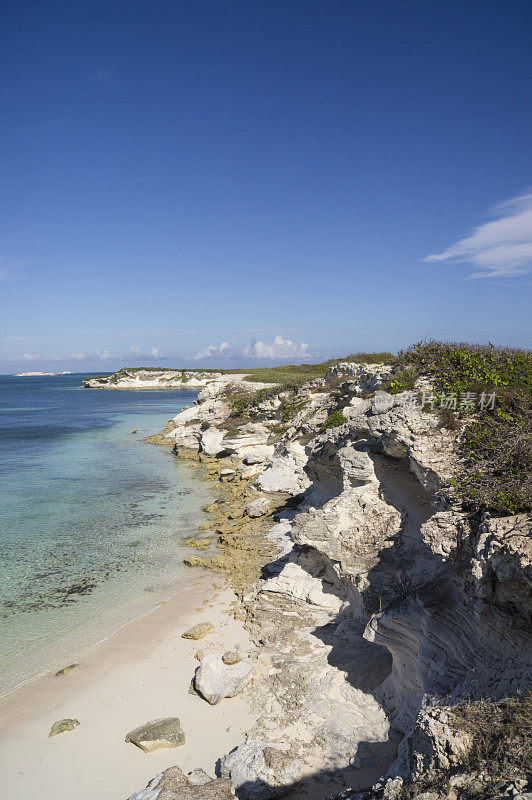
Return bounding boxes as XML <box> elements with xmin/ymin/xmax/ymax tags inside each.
<box><xmin>387</xmin><ymin>341</ymin><xmax>532</xmax><ymax>514</ymax></box>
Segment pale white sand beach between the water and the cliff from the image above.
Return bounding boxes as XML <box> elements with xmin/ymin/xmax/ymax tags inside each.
<box><xmin>0</xmin><ymin>576</ymin><xmax>253</xmax><ymax>800</ymax></box>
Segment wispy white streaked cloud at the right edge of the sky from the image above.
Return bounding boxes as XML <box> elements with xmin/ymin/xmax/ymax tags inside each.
<box><xmin>423</xmin><ymin>192</ymin><xmax>532</xmax><ymax>278</ymax></box>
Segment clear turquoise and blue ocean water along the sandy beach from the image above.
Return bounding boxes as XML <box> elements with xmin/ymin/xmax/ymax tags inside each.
<box><xmin>0</xmin><ymin>375</ymin><xmax>211</xmax><ymax>694</ymax></box>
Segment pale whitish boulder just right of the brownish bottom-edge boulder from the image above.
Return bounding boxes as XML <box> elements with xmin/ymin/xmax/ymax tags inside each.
<box><xmin>222</xmin><ymin>739</ymin><xmax>300</xmax><ymax>800</ymax></box>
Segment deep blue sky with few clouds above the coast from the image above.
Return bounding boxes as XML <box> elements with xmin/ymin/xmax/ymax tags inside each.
<box><xmin>0</xmin><ymin>0</ymin><xmax>532</xmax><ymax>372</ymax></box>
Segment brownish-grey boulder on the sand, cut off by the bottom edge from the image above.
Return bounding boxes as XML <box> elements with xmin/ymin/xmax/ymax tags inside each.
<box><xmin>129</xmin><ymin>767</ymin><xmax>234</xmax><ymax>800</ymax></box>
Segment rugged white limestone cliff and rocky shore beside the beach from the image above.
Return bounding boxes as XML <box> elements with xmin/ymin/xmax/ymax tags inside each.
<box><xmin>128</xmin><ymin>362</ymin><xmax>532</xmax><ymax>800</ymax></box>
